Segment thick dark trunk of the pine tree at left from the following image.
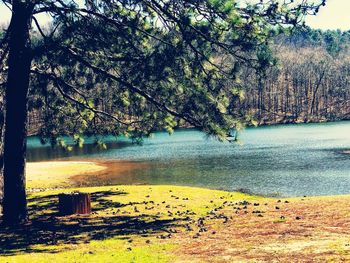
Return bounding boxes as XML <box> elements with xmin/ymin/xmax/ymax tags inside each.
<box><xmin>3</xmin><ymin>0</ymin><xmax>33</xmax><ymax>225</ymax></box>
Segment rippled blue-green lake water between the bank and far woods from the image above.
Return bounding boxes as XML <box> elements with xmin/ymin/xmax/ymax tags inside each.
<box><xmin>28</xmin><ymin>122</ymin><xmax>350</xmax><ymax>196</ymax></box>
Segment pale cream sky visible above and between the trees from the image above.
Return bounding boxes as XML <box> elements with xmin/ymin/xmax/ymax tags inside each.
<box><xmin>0</xmin><ymin>0</ymin><xmax>350</xmax><ymax>30</ymax></box>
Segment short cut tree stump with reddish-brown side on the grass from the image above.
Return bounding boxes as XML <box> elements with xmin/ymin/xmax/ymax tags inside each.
<box><xmin>58</xmin><ymin>193</ymin><xmax>91</xmax><ymax>215</ymax></box>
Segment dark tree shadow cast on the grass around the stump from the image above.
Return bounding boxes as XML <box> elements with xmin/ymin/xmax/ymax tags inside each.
<box><xmin>0</xmin><ymin>191</ymin><xmax>180</xmax><ymax>256</ymax></box>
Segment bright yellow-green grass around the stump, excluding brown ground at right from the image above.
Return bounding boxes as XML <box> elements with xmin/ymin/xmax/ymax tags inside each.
<box><xmin>0</xmin><ymin>185</ymin><xmax>259</xmax><ymax>263</ymax></box>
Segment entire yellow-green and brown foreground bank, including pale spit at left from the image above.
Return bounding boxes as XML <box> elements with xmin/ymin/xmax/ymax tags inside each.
<box><xmin>0</xmin><ymin>162</ymin><xmax>350</xmax><ymax>263</ymax></box>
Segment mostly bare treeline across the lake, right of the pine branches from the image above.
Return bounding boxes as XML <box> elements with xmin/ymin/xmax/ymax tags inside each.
<box><xmin>242</xmin><ymin>29</ymin><xmax>350</xmax><ymax>124</ymax></box>
